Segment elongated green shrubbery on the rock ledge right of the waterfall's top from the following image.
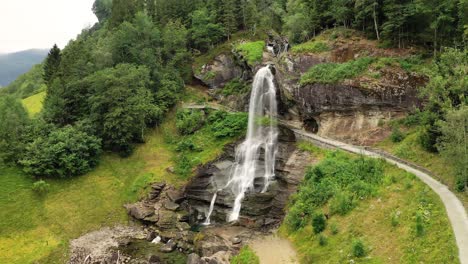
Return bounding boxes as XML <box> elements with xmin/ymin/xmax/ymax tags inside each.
<box><xmin>300</xmin><ymin>57</ymin><xmax>375</xmax><ymax>85</ymax></box>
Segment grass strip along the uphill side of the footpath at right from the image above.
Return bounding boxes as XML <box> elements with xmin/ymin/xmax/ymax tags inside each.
<box><xmin>375</xmin><ymin>128</ymin><xmax>468</xmax><ymax>208</ymax></box>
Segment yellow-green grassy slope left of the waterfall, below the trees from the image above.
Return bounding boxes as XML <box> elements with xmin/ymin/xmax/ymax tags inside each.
<box><xmin>0</xmin><ymin>85</ymin><xmax>236</xmax><ymax>264</ymax></box>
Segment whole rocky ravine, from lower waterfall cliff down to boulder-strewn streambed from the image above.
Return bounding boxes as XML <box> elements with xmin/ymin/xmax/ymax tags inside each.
<box><xmin>69</xmin><ymin>127</ymin><xmax>313</xmax><ymax>264</ymax></box>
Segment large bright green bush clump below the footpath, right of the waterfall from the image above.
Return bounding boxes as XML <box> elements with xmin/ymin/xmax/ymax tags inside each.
<box><xmin>286</xmin><ymin>151</ymin><xmax>384</xmax><ymax>231</ymax></box>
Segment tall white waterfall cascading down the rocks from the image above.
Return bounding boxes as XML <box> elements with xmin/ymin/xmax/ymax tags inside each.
<box><xmin>205</xmin><ymin>66</ymin><xmax>278</xmax><ymax>224</ymax></box>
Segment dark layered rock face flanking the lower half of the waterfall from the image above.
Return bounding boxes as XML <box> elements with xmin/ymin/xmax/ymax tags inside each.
<box><xmin>185</xmin><ymin>125</ymin><xmax>311</xmax><ymax>228</ymax></box>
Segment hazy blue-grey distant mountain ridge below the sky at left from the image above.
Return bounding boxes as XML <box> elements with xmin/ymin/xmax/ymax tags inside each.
<box><xmin>0</xmin><ymin>49</ymin><xmax>48</xmax><ymax>87</ymax></box>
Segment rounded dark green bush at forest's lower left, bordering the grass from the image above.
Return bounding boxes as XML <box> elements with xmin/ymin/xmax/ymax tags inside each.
<box><xmin>20</xmin><ymin>126</ymin><xmax>101</xmax><ymax>178</ymax></box>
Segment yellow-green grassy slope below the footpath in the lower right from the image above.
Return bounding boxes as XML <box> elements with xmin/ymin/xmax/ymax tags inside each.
<box><xmin>280</xmin><ymin>144</ymin><xmax>459</xmax><ymax>263</ymax></box>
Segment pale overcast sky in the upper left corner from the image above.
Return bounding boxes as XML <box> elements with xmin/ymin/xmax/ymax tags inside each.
<box><xmin>0</xmin><ymin>0</ymin><xmax>97</xmax><ymax>53</ymax></box>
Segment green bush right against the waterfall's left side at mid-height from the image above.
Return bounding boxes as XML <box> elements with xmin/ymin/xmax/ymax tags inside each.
<box><xmin>208</xmin><ymin>111</ymin><xmax>248</xmax><ymax>138</ymax></box>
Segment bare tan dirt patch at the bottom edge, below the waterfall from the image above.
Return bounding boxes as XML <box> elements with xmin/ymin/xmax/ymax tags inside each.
<box><xmin>249</xmin><ymin>234</ymin><xmax>299</xmax><ymax>264</ymax></box>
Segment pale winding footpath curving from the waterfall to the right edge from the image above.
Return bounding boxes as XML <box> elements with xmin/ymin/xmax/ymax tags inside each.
<box><xmin>288</xmin><ymin>125</ymin><xmax>468</xmax><ymax>264</ymax></box>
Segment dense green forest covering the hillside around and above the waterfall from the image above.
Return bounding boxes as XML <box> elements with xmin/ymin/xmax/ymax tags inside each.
<box><xmin>0</xmin><ymin>0</ymin><xmax>468</xmax><ymax>186</ymax></box>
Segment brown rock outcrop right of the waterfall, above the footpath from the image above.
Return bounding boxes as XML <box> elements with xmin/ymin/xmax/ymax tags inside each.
<box><xmin>276</xmin><ymin>38</ymin><xmax>427</xmax><ymax>144</ymax></box>
